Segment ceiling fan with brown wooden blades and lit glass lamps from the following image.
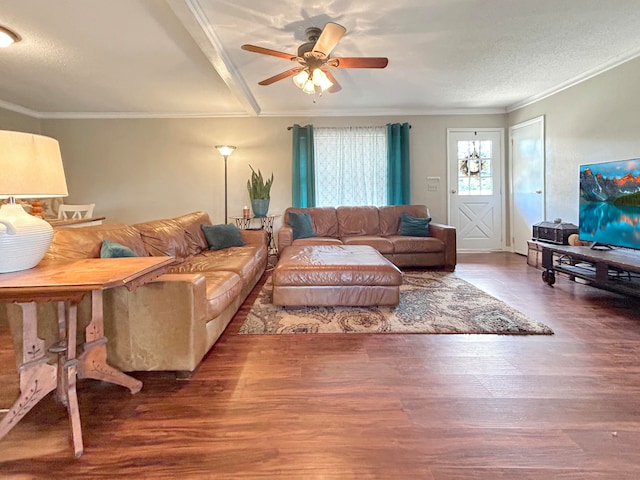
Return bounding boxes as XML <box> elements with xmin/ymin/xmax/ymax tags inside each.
<box><xmin>242</xmin><ymin>22</ymin><xmax>389</xmax><ymax>94</ymax></box>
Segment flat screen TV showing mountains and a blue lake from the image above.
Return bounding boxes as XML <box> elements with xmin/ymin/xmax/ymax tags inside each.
<box><xmin>579</xmin><ymin>158</ymin><xmax>640</xmax><ymax>249</ymax></box>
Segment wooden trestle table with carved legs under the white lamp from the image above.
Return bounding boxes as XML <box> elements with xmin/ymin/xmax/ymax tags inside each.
<box><xmin>0</xmin><ymin>257</ymin><xmax>173</xmax><ymax>457</ymax></box>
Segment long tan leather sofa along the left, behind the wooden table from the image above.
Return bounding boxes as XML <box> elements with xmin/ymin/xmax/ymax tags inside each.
<box><xmin>3</xmin><ymin>212</ymin><xmax>267</xmax><ymax>371</ymax></box>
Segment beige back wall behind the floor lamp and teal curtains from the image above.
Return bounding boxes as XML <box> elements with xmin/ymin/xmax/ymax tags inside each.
<box><xmin>42</xmin><ymin>115</ymin><xmax>505</xmax><ymax>223</ymax></box>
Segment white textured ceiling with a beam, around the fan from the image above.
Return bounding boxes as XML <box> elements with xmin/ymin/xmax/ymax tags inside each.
<box><xmin>0</xmin><ymin>0</ymin><xmax>640</xmax><ymax>118</ymax></box>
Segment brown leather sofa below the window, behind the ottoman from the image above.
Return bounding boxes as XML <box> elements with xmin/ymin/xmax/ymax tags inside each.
<box><xmin>278</xmin><ymin>205</ymin><xmax>457</xmax><ymax>271</ymax></box>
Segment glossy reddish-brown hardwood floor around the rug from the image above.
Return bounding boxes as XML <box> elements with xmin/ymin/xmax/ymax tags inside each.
<box><xmin>0</xmin><ymin>253</ymin><xmax>640</xmax><ymax>480</ymax></box>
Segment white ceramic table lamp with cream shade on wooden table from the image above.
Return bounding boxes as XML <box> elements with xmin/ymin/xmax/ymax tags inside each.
<box><xmin>0</xmin><ymin>130</ymin><xmax>68</xmax><ymax>273</ymax></box>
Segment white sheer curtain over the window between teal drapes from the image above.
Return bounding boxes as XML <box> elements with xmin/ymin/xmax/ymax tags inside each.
<box><xmin>314</xmin><ymin>127</ymin><xmax>387</xmax><ymax>207</ymax></box>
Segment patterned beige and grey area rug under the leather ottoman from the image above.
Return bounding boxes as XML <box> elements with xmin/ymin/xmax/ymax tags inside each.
<box><xmin>239</xmin><ymin>272</ymin><xmax>553</xmax><ymax>335</ymax></box>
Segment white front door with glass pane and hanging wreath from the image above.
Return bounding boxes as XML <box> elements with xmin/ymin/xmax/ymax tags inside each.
<box><xmin>447</xmin><ymin>129</ymin><xmax>504</xmax><ymax>251</ymax></box>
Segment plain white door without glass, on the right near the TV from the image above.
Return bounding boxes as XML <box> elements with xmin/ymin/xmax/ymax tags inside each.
<box><xmin>509</xmin><ymin>117</ymin><xmax>545</xmax><ymax>255</ymax></box>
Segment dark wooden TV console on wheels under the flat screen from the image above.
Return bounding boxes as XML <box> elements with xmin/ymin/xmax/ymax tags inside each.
<box><xmin>539</xmin><ymin>242</ymin><xmax>640</xmax><ymax>296</ymax></box>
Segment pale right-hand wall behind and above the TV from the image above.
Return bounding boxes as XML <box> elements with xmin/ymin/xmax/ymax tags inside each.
<box><xmin>508</xmin><ymin>59</ymin><xmax>640</xmax><ymax>225</ymax></box>
